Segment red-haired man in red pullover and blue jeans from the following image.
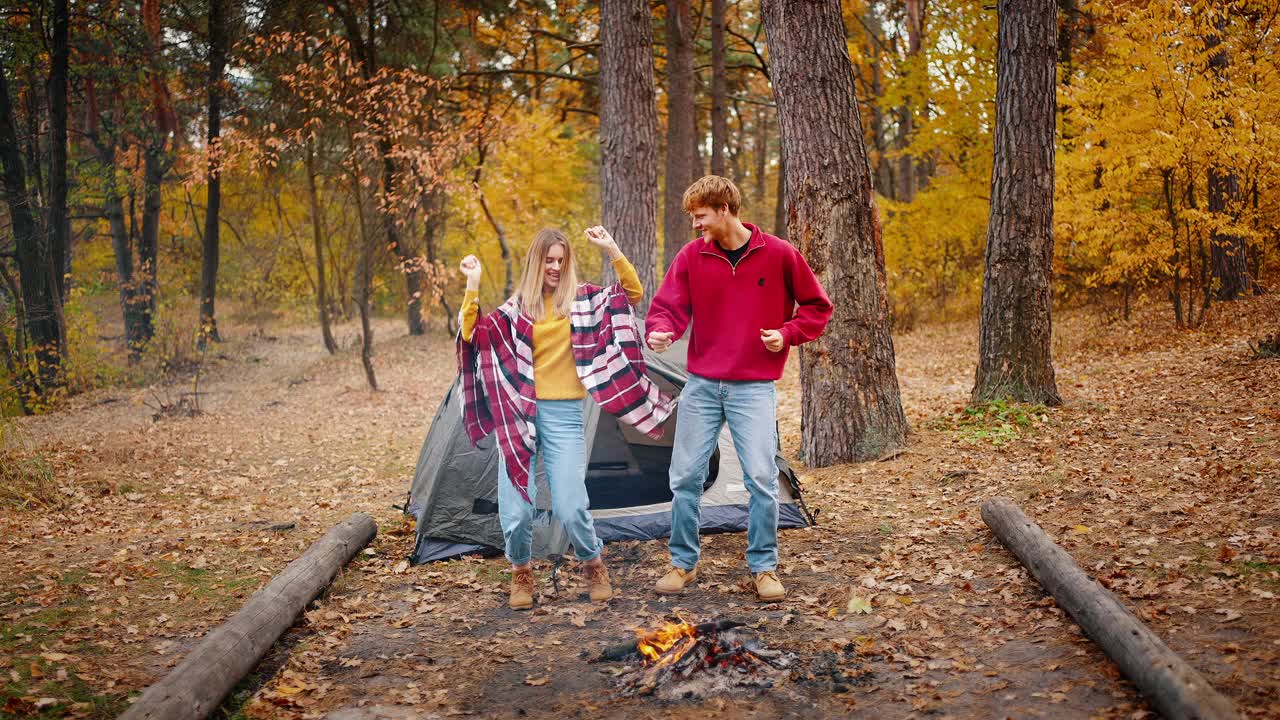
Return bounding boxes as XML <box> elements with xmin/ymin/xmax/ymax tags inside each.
<box><xmin>646</xmin><ymin>176</ymin><xmax>832</xmax><ymax>602</ymax></box>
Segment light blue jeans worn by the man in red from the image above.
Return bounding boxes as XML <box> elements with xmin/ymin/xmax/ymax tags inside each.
<box><xmin>668</xmin><ymin>374</ymin><xmax>778</xmax><ymax>573</ymax></box>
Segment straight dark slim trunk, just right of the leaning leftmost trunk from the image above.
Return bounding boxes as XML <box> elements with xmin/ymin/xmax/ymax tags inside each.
<box><xmin>49</xmin><ymin>0</ymin><xmax>72</xmax><ymax>304</ymax></box>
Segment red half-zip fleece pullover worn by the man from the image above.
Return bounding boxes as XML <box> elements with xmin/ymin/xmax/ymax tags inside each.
<box><xmin>645</xmin><ymin>223</ymin><xmax>832</xmax><ymax>380</ymax></box>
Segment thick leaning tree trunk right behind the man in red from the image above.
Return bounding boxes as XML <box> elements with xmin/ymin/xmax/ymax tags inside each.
<box><xmin>760</xmin><ymin>0</ymin><xmax>906</xmax><ymax>466</ymax></box>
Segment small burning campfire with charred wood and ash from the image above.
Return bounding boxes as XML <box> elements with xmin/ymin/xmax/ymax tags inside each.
<box><xmin>602</xmin><ymin>620</ymin><xmax>794</xmax><ymax>700</ymax></box>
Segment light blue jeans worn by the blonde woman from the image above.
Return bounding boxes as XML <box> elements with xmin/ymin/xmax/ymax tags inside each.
<box><xmin>498</xmin><ymin>400</ymin><xmax>603</xmax><ymax>565</ymax></box>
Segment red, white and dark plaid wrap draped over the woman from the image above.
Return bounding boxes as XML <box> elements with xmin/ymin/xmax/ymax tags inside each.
<box><xmin>458</xmin><ymin>278</ymin><xmax>675</xmax><ymax>501</ymax></box>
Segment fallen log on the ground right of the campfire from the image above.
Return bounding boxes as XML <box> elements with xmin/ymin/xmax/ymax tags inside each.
<box><xmin>982</xmin><ymin>497</ymin><xmax>1239</xmax><ymax>720</ymax></box>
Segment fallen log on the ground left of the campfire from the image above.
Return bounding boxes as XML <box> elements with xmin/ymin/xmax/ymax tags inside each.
<box><xmin>120</xmin><ymin>512</ymin><xmax>378</xmax><ymax>720</ymax></box>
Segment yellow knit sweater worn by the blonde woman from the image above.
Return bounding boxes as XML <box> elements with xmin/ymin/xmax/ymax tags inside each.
<box><xmin>462</xmin><ymin>258</ymin><xmax>644</xmax><ymax>400</ymax></box>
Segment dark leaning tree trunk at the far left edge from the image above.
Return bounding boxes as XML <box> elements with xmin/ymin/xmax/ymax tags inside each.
<box><xmin>0</xmin><ymin>58</ymin><xmax>64</xmax><ymax>395</ymax></box>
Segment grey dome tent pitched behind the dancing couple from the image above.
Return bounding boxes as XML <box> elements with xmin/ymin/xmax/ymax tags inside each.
<box><xmin>406</xmin><ymin>342</ymin><xmax>813</xmax><ymax>564</ymax></box>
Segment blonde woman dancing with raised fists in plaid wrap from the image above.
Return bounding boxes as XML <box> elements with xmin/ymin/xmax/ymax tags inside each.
<box><xmin>458</xmin><ymin>225</ymin><xmax>672</xmax><ymax>610</ymax></box>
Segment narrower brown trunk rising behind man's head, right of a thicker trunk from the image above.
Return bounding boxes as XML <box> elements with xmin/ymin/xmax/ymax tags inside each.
<box><xmin>662</xmin><ymin>0</ymin><xmax>701</xmax><ymax>269</ymax></box>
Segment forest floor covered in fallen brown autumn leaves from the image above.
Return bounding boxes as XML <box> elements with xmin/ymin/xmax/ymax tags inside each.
<box><xmin>0</xmin><ymin>296</ymin><xmax>1280</xmax><ymax>719</ymax></box>
